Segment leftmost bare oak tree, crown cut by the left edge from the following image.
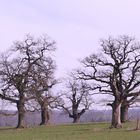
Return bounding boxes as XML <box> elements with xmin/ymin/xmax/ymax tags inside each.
<box><xmin>0</xmin><ymin>35</ymin><xmax>55</xmax><ymax>128</ymax></box>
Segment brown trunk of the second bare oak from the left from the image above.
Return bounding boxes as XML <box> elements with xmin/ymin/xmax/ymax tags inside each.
<box><xmin>40</xmin><ymin>103</ymin><xmax>50</xmax><ymax>125</ymax></box>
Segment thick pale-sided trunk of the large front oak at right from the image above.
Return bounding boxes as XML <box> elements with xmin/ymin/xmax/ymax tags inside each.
<box><xmin>111</xmin><ymin>101</ymin><xmax>122</xmax><ymax>128</ymax></box>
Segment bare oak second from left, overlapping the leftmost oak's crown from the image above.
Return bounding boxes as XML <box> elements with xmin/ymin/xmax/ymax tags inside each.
<box><xmin>29</xmin><ymin>62</ymin><xmax>57</xmax><ymax>125</ymax></box>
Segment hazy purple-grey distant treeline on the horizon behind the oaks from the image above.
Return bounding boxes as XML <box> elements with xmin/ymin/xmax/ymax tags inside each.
<box><xmin>0</xmin><ymin>109</ymin><xmax>140</xmax><ymax>127</ymax></box>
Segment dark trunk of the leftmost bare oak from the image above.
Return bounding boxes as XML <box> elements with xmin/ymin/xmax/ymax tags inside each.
<box><xmin>17</xmin><ymin>101</ymin><xmax>25</xmax><ymax>128</ymax></box>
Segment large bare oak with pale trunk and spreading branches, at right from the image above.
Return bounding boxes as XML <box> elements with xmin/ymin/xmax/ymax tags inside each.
<box><xmin>78</xmin><ymin>36</ymin><xmax>140</xmax><ymax>128</ymax></box>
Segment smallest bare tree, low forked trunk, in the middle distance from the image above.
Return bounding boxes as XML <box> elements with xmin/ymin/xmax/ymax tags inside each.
<box><xmin>58</xmin><ymin>77</ymin><xmax>93</xmax><ymax>123</ymax></box>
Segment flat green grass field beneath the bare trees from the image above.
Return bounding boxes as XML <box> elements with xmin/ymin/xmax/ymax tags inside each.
<box><xmin>0</xmin><ymin>122</ymin><xmax>140</xmax><ymax>140</ymax></box>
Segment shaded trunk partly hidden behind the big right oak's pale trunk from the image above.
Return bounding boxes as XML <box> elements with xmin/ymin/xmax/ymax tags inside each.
<box><xmin>121</xmin><ymin>105</ymin><xmax>129</xmax><ymax>123</ymax></box>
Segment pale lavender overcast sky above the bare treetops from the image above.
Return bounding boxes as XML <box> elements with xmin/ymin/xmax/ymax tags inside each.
<box><xmin>0</xmin><ymin>0</ymin><xmax>140</xmax><ymax>76</ymax></box>
